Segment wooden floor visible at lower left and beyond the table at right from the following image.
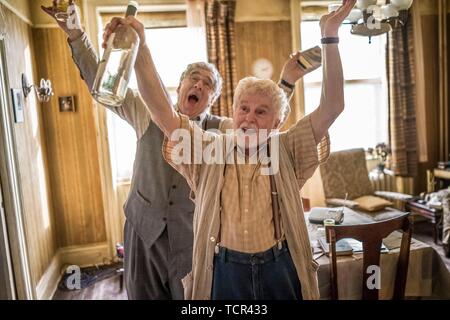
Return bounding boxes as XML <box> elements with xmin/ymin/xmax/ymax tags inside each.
<box><xmin>53</xmin><ymin>222</ymin><xmax>450</xmax><ymax>300</ymax></box>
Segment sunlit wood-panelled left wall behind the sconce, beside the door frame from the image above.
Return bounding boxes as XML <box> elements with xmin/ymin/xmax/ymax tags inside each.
<box><xmin>0</xmin><ymin>4</ymin><xmax>57</xmax><ymax>285</ymax></box>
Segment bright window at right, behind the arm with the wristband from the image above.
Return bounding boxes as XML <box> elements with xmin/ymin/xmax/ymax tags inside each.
<box><xmin>301</xmin><ymin>21</ymin><xmax>388</xmax><ymax>151</ymax></box>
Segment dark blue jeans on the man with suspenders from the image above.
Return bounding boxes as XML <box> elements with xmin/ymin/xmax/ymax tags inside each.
<box><xmin>211</xmin><ymin>241</ymin><xmax>302</xmax><ymax>300</ymax></box>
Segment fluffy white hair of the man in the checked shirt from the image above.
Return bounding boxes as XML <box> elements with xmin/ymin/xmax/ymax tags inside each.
<box><xmin>233</xmin><ymin>77</ymin><xmax>291</xmax><ymax>127</ymax></box>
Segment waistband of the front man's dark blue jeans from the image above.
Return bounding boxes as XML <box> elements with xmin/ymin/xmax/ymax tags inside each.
<box><xmin>215</xmin><ymin>240</ymin><xmax>289</xmax><ymax>265</ymax></box>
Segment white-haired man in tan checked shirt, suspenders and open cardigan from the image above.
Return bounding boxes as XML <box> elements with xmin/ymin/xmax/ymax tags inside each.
<box><xmin>101</xmin><ymin>0</ymin><xmax>356</xmax><ymax>299</ymax></box>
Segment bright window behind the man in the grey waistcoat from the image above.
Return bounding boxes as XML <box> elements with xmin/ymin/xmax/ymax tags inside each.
<box><xmin>107</xmin><ymin>27</ymin><xmax>207</xmax><ymax>183</ymax></box>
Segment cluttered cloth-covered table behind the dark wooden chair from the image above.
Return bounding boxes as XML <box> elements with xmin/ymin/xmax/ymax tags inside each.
<box><xmin>305</xmin><ymin>208</ymin><xmax>450</xmax><ymax>299</ymax></box>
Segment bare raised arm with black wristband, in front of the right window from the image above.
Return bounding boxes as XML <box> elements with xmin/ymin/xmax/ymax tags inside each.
<box><xmin>311</xmin><ymin>0</ymin><xmax>356</xmax><ymax>142</ymax></box>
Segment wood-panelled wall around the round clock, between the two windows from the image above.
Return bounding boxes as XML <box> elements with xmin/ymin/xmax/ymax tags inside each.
<box><xmin>236</xmin><ymin>21</ymin><xmax>295</xmax><ymax>129</ymax></box>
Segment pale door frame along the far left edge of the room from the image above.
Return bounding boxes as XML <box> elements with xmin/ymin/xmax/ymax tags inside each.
<box><xmin>0</xmin><ymin>35</ymin><xmax>36</xmax><ymax>300</ymax></box>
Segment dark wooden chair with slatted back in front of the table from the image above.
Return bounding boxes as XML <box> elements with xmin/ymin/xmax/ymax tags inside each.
<box><xmin>326</xmin><ymin>213</ymin><xmax>412</xmax><ymax>300</ymax></box>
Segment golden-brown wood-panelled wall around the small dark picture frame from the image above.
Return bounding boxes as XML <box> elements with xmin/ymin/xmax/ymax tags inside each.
<box><xmin>34</xmin><ymin>29</ymin><xmax>106</xmax><ymax>247</ymax></box>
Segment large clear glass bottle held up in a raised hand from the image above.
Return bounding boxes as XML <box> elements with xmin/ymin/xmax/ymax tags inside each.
<box><xmin>92</xmin><ymin>1</ymin><xmax>140</xmax><ymax>107</ymax></box>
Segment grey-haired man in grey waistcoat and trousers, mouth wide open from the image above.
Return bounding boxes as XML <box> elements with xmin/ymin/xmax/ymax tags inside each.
<box><xmin>42</xmin><ymin>0</ymin><xmax>305</xmax><ymax>299</ymax></box>
